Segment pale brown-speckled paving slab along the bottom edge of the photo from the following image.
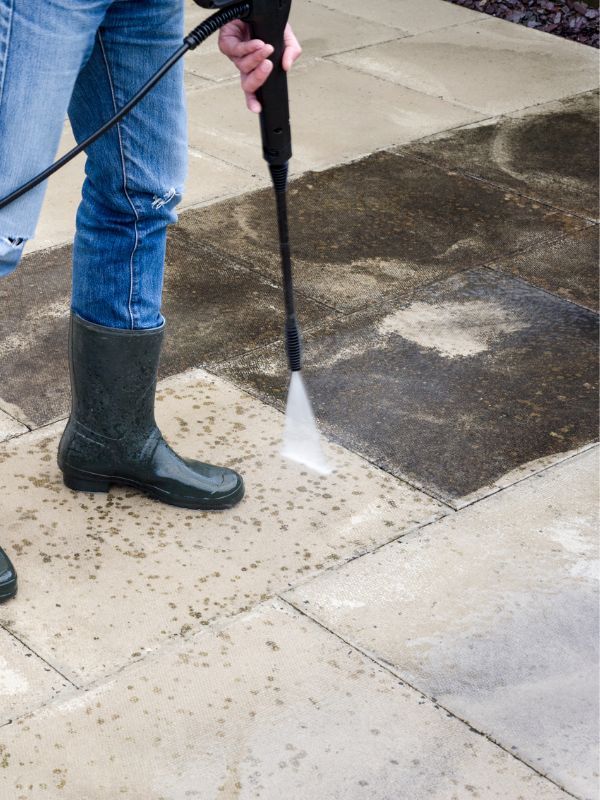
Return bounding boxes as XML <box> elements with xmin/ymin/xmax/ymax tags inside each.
<box><xmin>0</xmin><ymin>604</ymin><xmax>567</xmax><ymax>800</ymax></box>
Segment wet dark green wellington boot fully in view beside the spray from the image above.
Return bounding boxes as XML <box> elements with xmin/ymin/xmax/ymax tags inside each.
<box><xmin>58</xmin><ymin>314</ymin><xmax>244</xmax><ymax>510</ymax></box>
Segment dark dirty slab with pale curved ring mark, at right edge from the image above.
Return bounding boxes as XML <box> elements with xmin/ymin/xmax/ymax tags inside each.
<box><xmin>400</xmin><ymin>92</ymin><xmax>598</xmax><ymax>219</ymax></box>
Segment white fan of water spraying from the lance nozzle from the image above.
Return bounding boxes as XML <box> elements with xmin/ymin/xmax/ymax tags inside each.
<box><xmin>281</xmin><ymin>372</ymin><xmax>333</xmax><ymax>475</ymax></box>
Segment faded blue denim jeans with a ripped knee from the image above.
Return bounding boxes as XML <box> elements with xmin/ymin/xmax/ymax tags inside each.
<box><xmin>0</xmin><ymin>0</ymin><xmax>187</xmax><ymax>328</ymax></box>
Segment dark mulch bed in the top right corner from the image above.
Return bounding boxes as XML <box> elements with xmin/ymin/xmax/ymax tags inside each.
<box><xmin>449</xmin><ymin>0</ymin><xmax>599</xmax><ymax>47</ymax></box>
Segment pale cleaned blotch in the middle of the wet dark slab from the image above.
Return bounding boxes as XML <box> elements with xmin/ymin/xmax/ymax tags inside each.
<box><xmin>378</xmin><ymin>300</ymin><xmax>527</xmax><ymax>358</ymax></box>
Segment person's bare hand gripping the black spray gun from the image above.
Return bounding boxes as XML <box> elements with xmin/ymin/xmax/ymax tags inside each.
<box><xmin>219</xmin><ymin>19</ymin><xmax>302</xmax><ymax>114</ymax></box>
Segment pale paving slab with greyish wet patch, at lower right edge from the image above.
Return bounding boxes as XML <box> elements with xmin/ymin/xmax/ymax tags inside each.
<box><xmin>287</xmin><ymin>449</ymin><xmax>598</xmax><ymax>800</ymax></box>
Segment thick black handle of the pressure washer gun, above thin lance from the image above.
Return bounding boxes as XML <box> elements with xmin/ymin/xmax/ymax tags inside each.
<box><xmin>247</xmin><ymin>0</ymin><xmax>292</xmax><ymax>165</ymax></box>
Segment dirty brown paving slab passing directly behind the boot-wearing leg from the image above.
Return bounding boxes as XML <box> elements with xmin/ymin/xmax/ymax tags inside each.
<box><xmin>0</xmin><ymin>225</ymin><xmax>331</xmax><ymax>428</ymax></box>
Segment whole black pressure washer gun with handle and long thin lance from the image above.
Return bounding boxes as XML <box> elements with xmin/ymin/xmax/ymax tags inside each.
<box><xmin>194</xmin><ymin>0</ymin><xmax>302</xmax><ymax>372</ymax></box>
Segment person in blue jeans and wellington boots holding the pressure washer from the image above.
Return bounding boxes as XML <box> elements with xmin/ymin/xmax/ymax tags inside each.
<box><xmin>0</xmin><ymin>0</ymin><xmax>301</xmax><ymax>601</ymax></box>
